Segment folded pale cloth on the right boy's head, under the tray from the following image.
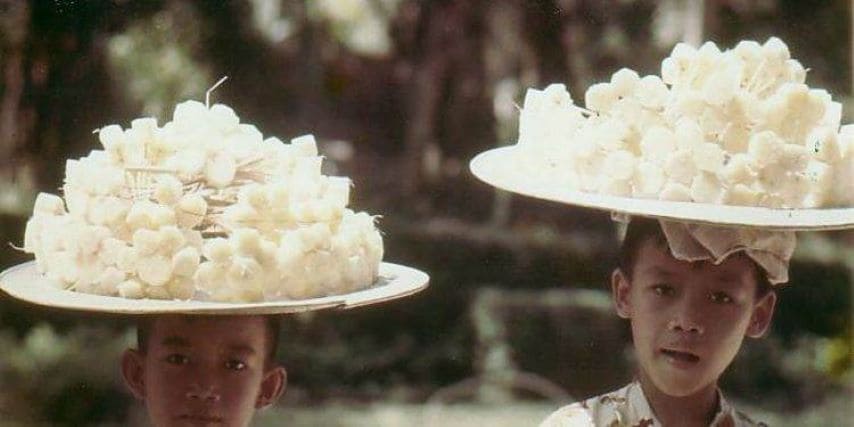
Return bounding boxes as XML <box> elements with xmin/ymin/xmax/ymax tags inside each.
<box><xmin>614</xmin><ymin>215</ymin><xmax>797</xmax><ymax>285</ymax></box>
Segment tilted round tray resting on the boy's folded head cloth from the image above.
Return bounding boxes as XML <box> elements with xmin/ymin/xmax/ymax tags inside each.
<box><xmin>469</xmin><ymin>146</ymin><xmax>854</xmax><ymax>230</ymax></box>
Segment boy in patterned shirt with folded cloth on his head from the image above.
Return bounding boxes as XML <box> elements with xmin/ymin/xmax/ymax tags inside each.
<box><xmin>541</xmin><ymin>218</ymin><xmax>795</xmax><ymax>427</ymax></box>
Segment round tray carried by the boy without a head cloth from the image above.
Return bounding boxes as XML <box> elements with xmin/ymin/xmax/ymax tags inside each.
<box><xmin>0</xmin><ymin>261</ymin><xmax>430</xmax><ymax>314</ymax></box>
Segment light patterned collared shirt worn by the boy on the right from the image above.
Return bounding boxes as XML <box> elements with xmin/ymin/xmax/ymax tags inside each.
<box><xmin>540</xmin><ymin>381</ymin><xmax>767</xmax><ymax>427</ymax></box>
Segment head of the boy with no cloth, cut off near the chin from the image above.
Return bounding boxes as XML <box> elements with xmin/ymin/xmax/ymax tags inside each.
<box><xmin>122</xmin><ymin>316</ymin><xmax>286</xmax><ymax>426</ymax></box>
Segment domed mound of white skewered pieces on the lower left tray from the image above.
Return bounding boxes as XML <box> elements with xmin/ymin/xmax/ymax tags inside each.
<box><xmin>24</xmin><ymin>101</ymin><xmax>383</xmax><ymax>302</ymax></box>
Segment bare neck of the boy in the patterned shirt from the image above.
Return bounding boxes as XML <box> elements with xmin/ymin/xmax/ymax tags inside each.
<box><xmin>638</xmin><ymin>372</ymin><xmax>720</xmax><ymax>427</ymax></box>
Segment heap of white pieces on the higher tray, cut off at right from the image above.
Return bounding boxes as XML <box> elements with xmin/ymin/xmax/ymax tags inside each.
<box><xmin>508</xmin><ymin>38</ymin><xmax>854</xmax><ymax>208</ymax></box>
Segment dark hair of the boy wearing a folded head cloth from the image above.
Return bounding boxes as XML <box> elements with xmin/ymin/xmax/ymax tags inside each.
<box><xmin>618</xmin><ymin>217</ymin><xmax>773</xmax><ymax>299</ymax></box>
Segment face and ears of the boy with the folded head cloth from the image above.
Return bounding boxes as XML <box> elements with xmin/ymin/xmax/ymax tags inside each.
<box><xmin>612</xmin><ymin>239</ymin><xmax>776</xmax><ymax>397</ymax></box>
